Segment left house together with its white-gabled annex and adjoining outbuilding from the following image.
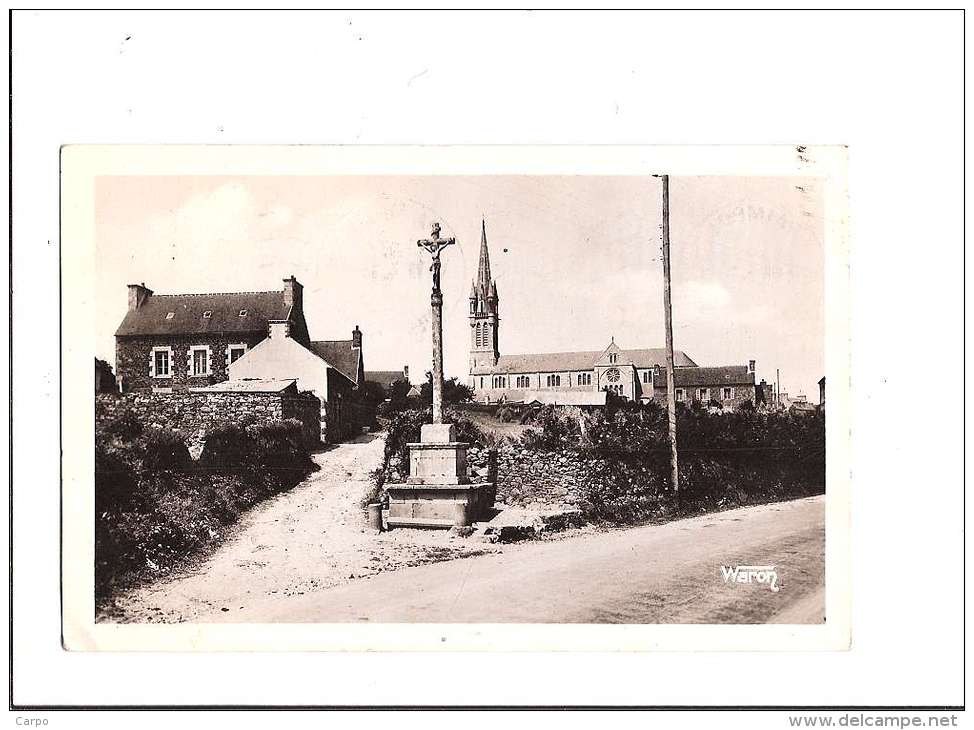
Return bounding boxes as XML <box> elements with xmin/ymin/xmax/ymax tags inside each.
<box><xmin>115</xmin><ymin>276</ymin><xmax>367</xmax><ymax>442</ymax></box>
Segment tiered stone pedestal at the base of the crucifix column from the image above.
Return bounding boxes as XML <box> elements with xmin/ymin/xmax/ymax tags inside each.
<box><xmin>385</xmin><ymin>423</ymin><xmax>494</xmax><ymax>528</ymax></box>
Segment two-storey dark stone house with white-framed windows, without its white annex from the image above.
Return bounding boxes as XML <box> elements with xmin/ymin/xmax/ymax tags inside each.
<box><xmin>115</xmin><ymin>276</ymin><xmax>311</xmax><ymax>392</ymax></box>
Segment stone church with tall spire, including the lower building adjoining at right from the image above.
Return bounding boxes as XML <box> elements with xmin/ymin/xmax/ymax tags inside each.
<box><xmin>467</xmin><ymin>222</ymin><xmax>757</xmax><ymax>409</ymax></box>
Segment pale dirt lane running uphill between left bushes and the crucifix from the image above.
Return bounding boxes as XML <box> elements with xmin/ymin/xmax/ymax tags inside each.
<box><xmin>106</xmin><ymin>436</ymin><xmax>499</xmax><ymax>622</ymax></box>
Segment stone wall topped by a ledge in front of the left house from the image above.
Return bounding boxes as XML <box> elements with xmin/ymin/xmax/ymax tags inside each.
<box><xmin>95</xmin><ymin>391</ymin><xmax>321</xmax><ymax>456</ymax></box>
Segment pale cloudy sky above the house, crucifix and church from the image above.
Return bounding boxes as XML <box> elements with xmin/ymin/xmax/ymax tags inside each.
<box><xmin>95</xmin><ymin>175</ymin><xmax>825</xmax><ymax>402</ymax></box>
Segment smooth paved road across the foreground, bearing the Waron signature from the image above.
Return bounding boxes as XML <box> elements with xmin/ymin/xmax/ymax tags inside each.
<box><xmin>231</xmin><ymin>497</ymin><xmax>825</xmax><ymax>623</ymax></box>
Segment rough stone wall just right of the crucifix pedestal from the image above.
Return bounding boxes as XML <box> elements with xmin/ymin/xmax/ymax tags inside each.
<box><xmin>467</xmin><ymin>446</ymin><xmax>604</xmax><ymax>508</ymax></box>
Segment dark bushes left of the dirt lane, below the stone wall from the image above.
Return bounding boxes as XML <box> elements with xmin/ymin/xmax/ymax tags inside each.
<box><xmin>95</xmin><ymin>412</ymin><xmax>314</xmax><ymax>603</ymax></box>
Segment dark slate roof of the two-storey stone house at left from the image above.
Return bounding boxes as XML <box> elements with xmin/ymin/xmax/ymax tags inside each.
<box><xmin>115</xmin><ymin>291</ymin><xmax>289</xmax><ymax>337</ymax></box>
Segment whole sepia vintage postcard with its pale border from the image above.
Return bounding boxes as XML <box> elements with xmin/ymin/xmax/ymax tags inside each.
<box><xmin>62</xmin><ymin>146</ymin><xmax>851</xmax><ymax>651</ymax></box>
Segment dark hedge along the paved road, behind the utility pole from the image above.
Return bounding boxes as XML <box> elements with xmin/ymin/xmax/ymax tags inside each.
<box><xmin>521</xmin><ymin>402</ymin><xmax>825</xmax><ymax>523</ymax></box>
